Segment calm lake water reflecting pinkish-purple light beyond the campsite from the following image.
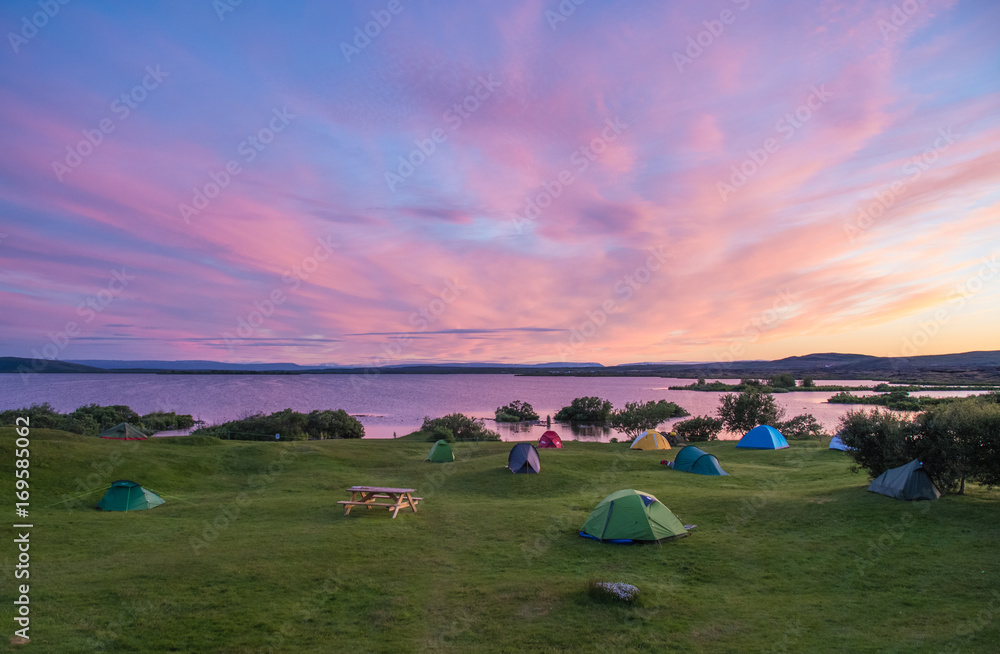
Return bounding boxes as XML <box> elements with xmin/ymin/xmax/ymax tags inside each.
<box><xmin>0</xmin><ymin>374</ymin><xmax>980</xmax><ymax>441</ymax></box>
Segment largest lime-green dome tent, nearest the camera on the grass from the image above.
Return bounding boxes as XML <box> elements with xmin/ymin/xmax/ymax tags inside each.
<box><xmin>580</xmin><ymin>489</ymin><xmax>688</xmax><ymax>543</ymax></box>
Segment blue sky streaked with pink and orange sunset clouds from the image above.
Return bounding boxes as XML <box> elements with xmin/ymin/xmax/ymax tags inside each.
<box><xmin>0</xmin><ymin>0</ymin><xmax>1000</xmax><ymax>366</ymax></box>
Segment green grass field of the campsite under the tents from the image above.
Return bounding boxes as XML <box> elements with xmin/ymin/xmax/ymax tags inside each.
<box><xmin>0</xmin><ymin>428</ymin><xmax>1000</xmax><ymax>653</ymax></box>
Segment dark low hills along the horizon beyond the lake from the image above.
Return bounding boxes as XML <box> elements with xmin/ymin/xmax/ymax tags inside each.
<box><xmin>0</xmin><ymin>350</ymin><xmax>1000</xmax><ymax>382</ymax></box>
